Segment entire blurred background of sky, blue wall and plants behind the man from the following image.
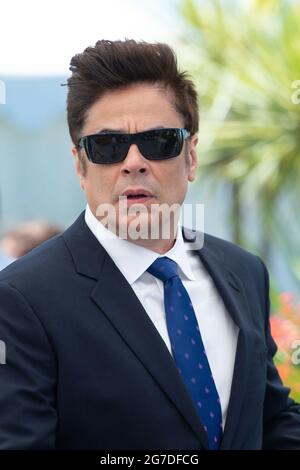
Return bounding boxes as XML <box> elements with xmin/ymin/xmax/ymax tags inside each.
<box><xmin>0</xmin><ymin>0</ymin><xmax>300</xmax><ymax>400</ymax></box>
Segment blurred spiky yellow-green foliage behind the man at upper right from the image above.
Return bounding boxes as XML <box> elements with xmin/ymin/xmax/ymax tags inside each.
<box><xmin>180</xmin><ymin>0</ymin><xmax>300</xmax><ymax>282</ymax></box>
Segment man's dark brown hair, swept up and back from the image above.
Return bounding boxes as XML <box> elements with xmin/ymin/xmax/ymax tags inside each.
<box><xmin>67</xmin><ymin>39</ymin><xmax>199</xmax><ymax>146</ymax></box>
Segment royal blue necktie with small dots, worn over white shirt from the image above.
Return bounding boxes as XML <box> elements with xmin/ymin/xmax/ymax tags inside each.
<box><xmin>147</xmin><ymin>256</ymin><xmax>222</xmax><ymax>449</ymax></box>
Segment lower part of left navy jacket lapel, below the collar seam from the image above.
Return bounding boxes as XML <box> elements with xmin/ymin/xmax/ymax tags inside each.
<box><xmin>91</xmin><ymin>252</ymin><xmax>207</xmax><ymax>445</ymax></box>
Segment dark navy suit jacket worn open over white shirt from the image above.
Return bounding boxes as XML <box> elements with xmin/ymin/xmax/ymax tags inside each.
<box><xmin>0</xmin><ymin>212</ymin><xmax>300</xmax><ymax>450</ymax></box>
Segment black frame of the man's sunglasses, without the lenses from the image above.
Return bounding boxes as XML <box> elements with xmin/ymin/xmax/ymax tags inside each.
<box><xmin>78</xmin><ymin>127</ymin><xmax>191</xmax><ymax>165</ymax></box>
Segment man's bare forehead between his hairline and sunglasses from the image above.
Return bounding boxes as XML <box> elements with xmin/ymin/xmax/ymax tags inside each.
<box><xmin>84</xmin><ymin>84</ymin><xmax>183</xmax><ymax>133</ymax></box>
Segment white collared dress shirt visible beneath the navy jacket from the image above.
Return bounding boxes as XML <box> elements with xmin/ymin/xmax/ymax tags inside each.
<box><xmin>85</xmin><ymin>204</ymin><xmax>238</xmax><ymax>429</ymax></box>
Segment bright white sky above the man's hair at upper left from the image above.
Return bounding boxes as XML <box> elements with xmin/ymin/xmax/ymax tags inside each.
<box><xmin>0</xmin><ymin>0</ymin><xmax>177</xmax><ymax>78</ymax></box>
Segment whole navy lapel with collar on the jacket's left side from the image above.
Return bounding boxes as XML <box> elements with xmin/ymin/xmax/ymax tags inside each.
<box><xmin>63</xmin><ymin>212</ymin><xmax>208</xmax><ymax>448</ymax></box>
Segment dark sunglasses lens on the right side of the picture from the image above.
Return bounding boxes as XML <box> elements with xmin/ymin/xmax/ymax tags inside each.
<box><xmin>138</xmin><ymin>129</ymin><xmax>183</xmax><ymax>160</ymax></box>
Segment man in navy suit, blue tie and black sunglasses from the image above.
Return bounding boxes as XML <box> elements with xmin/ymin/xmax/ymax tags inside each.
<box><xmin>0</xmin><ymin>40</ymin><xmax>300</xmax><ymax>450</ymax></box>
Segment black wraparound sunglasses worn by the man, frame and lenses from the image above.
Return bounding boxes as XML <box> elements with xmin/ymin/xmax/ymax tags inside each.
<box><xmin>78</xmin><ymin>128</ymin><xmax>190</xmax><ymax>163</ymax></box>
